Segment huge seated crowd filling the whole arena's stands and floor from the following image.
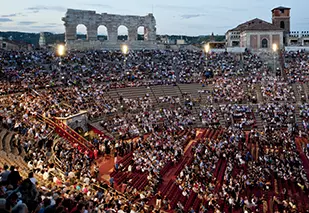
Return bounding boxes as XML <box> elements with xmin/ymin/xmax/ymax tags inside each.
<box><xmin>0</xmin><ymin>50</ymin><xmax>309</xmax><ymax>213</ymax></box>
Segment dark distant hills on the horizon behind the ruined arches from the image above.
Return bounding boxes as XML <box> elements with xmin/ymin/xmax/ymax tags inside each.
<box><xmin>0</xmin><ymin>31</ymin><xmax>225</xmax><ymax>46</ymax></box>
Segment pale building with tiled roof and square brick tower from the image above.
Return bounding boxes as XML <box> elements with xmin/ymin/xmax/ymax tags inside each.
<box><xmin>226</xmin><ymin>7</ymin><xmax>290</xmax><ymax>50</ymax></box>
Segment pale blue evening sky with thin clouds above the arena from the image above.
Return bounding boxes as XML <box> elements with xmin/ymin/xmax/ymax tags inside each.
<box><xmin>0</xmin><ymin>0</ymin><xmax>309</xmax><ymax>35</ymax></box>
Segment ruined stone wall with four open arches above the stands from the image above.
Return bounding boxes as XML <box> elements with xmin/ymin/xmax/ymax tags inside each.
<box><xmin>62</xmin><ymin>9</ymin><xmax>156</xmax><ymax>49</ymax></box>
